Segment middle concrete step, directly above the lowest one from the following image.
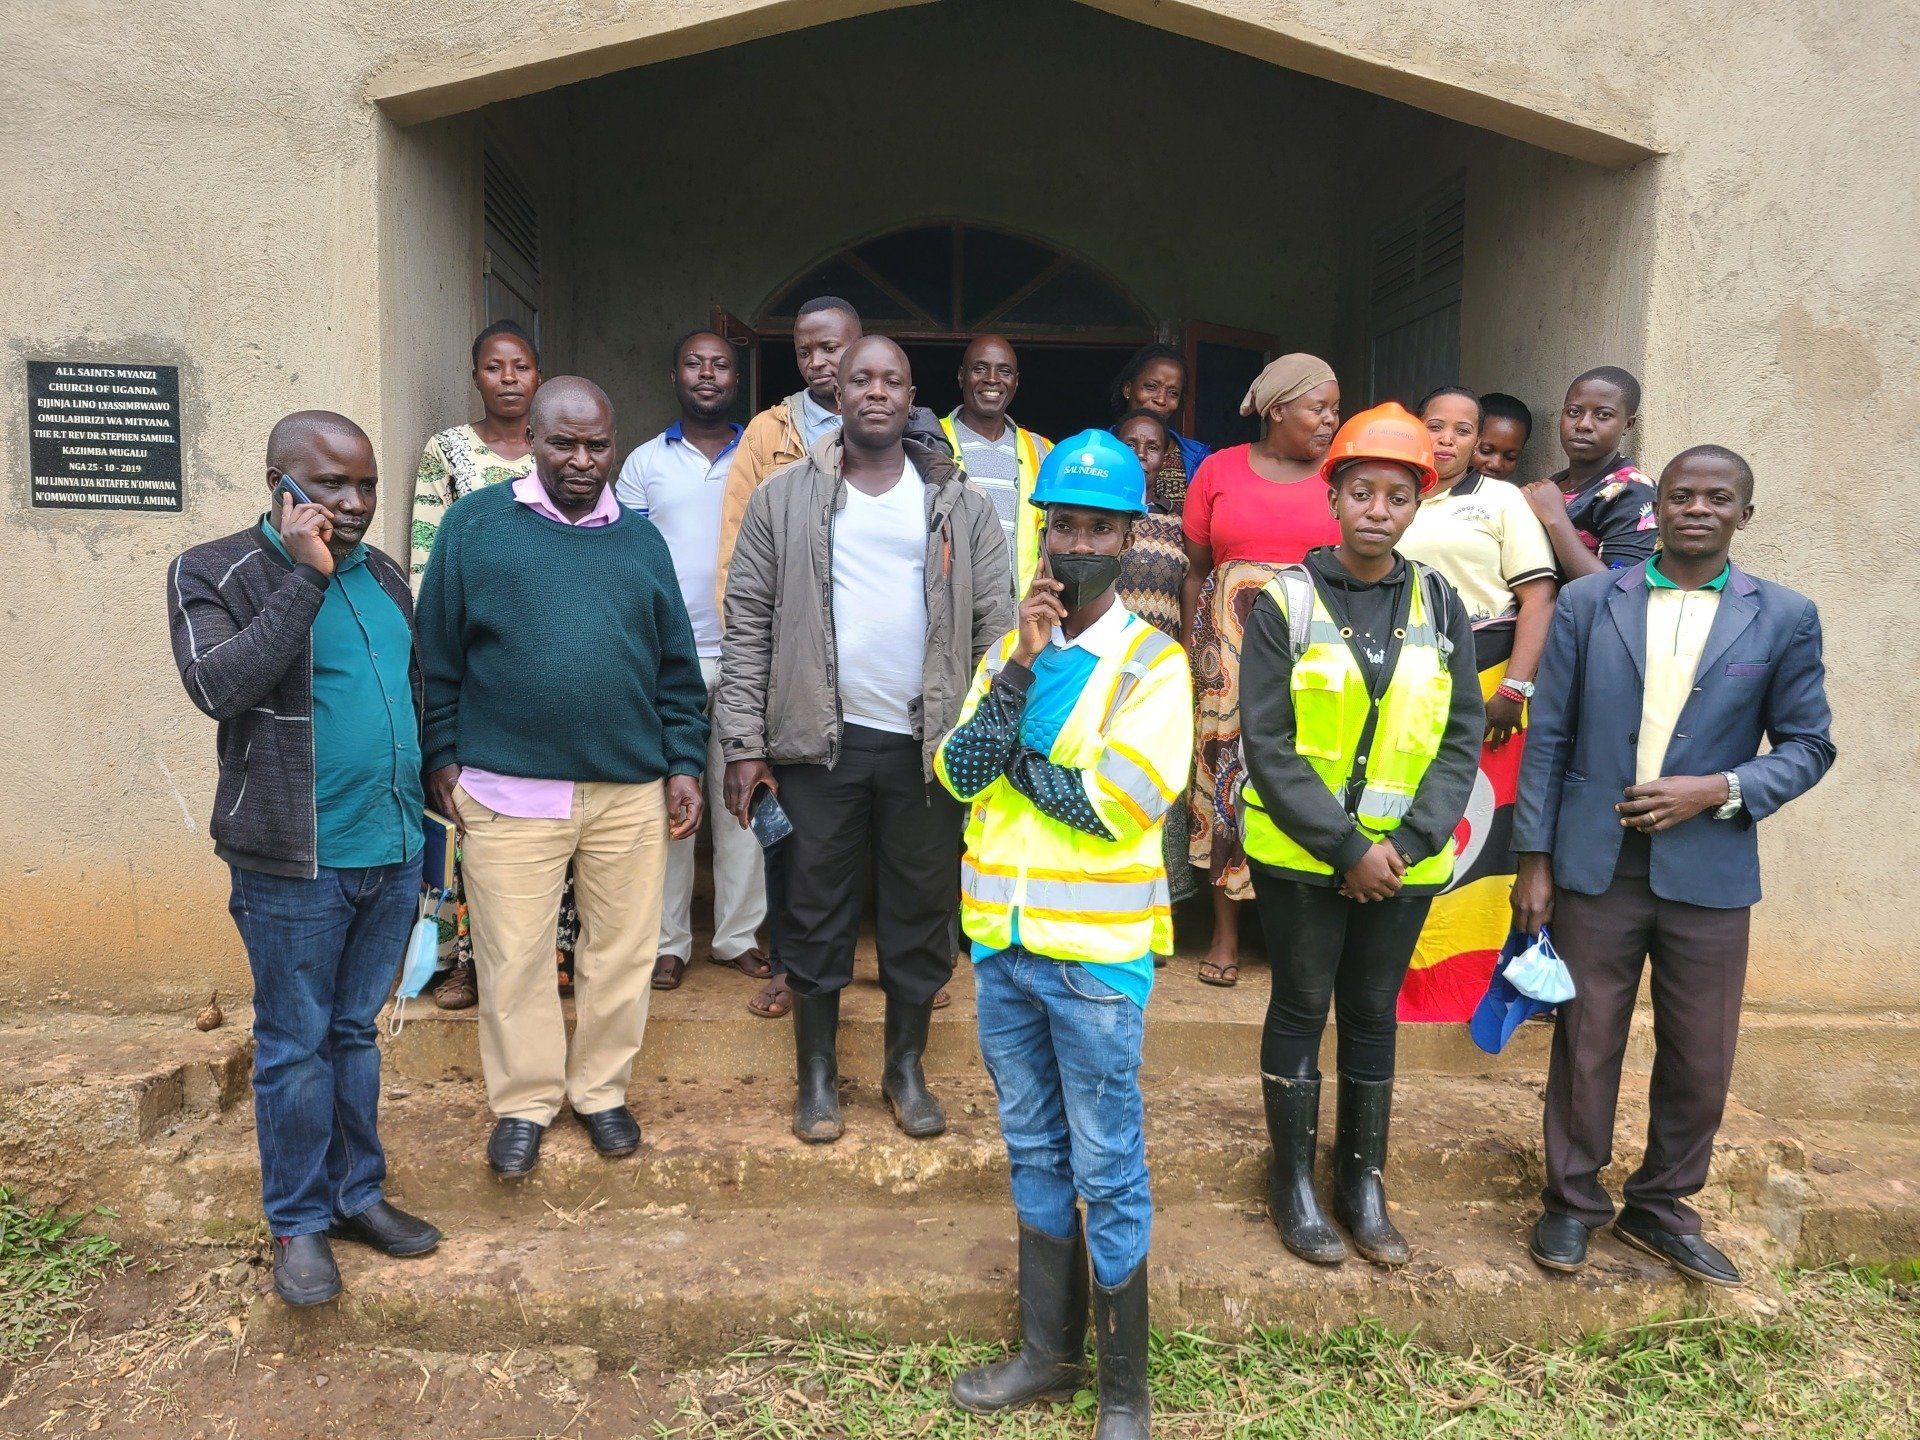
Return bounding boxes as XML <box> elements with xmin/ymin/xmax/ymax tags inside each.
<box><xmin>102</xmin><ymin>1075</ymin><xmax>1803</xmax><ymax>1236</ymax></box>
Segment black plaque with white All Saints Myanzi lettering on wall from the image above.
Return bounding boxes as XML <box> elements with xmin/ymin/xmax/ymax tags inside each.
<box><xmin>27</xmin><ymin>361</ymin><xmax>182</xmax><ymax>511</ymax></box>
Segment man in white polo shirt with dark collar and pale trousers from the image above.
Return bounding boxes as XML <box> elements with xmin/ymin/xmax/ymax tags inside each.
<box><xmin>614</xmin><ymin>330</ymin><xmax>768</xmax><ymax>991</ymax></box>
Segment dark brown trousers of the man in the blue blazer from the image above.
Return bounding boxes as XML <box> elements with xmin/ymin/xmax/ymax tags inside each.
<box><xmin>1542</xmin><ymin>867</ymin><xmax>1753</xmax><ymax>1235</ymax></box>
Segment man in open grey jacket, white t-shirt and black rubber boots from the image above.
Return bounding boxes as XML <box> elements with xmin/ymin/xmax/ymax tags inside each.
<box><xmin>714</xmin><ymin>336</ymin><xmax>1014</xmax><ymax>1142</ymax></box>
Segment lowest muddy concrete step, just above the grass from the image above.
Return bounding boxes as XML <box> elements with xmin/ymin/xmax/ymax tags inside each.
<box><xmin>248</xmin><ymin>1204</ymin><xmax>1772</xmax><ymax>1365</ymax></box>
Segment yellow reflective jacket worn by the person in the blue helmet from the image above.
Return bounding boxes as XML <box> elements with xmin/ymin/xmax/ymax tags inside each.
<box><xmin>933</xmin><ymin>614</ymin><xmax>1194</xmax><ymax>964</ymax></box>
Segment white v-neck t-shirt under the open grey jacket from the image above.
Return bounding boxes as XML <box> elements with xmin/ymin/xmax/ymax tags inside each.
<box><xmin>833</xmin><ymin>461</ymin><xmax>927</xmax><ymax>735</ymax></box>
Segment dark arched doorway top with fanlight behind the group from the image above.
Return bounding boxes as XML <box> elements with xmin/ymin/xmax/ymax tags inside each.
<box><xmin>724</xmin><ymin>221</ymin><xmax>1154</xmax><ymax>436</ymax></box>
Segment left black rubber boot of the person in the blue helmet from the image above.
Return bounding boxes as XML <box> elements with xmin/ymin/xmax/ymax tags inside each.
<box><xmin>950</xmin><ymin>1213</ymin><xmax>1087</xmax><ymax>1415</ymax></box>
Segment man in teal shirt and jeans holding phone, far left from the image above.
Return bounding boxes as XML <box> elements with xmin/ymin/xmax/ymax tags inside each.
<box><xmin>167</xmin><ymin>411</ymin><xmax>440</xmax><ymax>1306</ymax></box>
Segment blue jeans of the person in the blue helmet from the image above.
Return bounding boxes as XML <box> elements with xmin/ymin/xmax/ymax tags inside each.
<box><xmin>973</xmin><ymin>945</ymin><xmax>1154</xmax><ymax>1286</ymax></box>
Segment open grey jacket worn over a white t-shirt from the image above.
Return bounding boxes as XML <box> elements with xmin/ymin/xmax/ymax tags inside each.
<box><xmin>714</xmin><ymin>434</ymin><xmax>1014</xmax><ymax>780</ymax></box>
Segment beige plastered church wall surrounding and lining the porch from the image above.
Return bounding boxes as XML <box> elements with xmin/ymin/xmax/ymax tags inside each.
<box><xmin>0</xmin><ymin>0</ymin><xmax>1920</xmax><ymax>1010</ymax></box>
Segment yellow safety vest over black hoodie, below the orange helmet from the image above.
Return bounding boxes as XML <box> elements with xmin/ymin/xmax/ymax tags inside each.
<box><xmin>1240</xmin><ymin>563</ymin><xmax>1453</xmax><ymax>885</ymax></box>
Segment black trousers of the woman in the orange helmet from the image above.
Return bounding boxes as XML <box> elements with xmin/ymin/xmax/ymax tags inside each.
<box><xmin>1250</xmin><ymin>864</ymin><xmax>1432</xmax><ymax>1081</ymax></box>
